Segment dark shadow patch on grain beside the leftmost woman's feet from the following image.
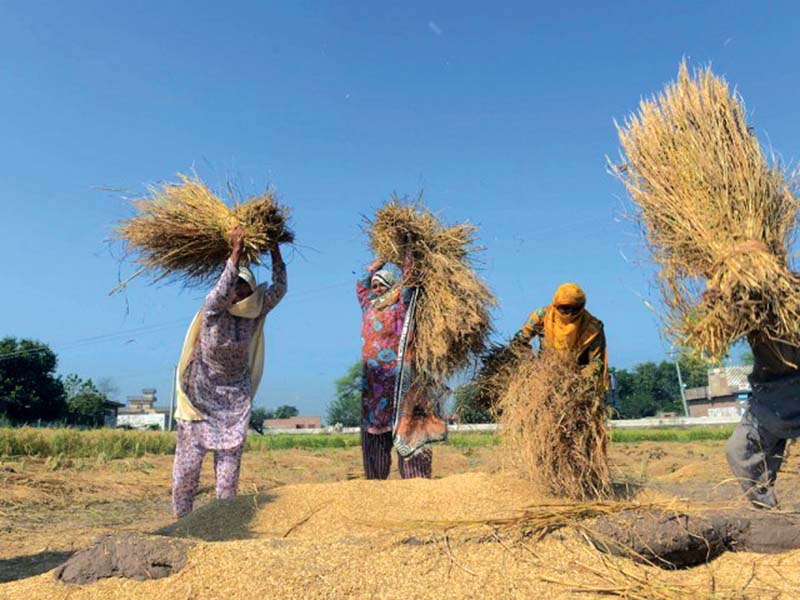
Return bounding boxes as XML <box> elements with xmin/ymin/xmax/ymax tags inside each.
<box><xmin>153</xmin><ymin>494</ymin><xmax>275</xmax><ymax>542</ymax></box>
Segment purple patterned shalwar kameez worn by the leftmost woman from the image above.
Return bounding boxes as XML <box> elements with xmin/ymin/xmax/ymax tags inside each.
<box><xmin>172</xmin><ymin>260</ymin><xmax>286</xmax><ymax>517</ymax></box>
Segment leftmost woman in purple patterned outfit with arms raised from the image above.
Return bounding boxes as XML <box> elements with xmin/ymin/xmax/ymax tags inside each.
<box><xmin>172</xmin><ymin>227</ymin><xmax>286</xmax><ymax>517</ymax></box>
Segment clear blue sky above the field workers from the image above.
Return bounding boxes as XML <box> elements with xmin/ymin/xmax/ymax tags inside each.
<box><xmin>0</xmin><ymin>0</ymin><xmax>800</xmax><ymax>414</ymax></box>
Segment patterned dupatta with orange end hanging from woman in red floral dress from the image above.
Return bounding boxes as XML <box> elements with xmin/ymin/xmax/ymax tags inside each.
<box><xmin>392</xmin><ymin>288</ymin><xmax>447</xmax><ymax>458</ymax></box>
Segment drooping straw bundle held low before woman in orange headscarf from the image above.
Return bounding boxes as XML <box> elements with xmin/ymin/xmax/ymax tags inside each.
<box><xmin>498</xmin><ymin>350</ymin><xmax>610</xmax><ymax>499</ymax></box>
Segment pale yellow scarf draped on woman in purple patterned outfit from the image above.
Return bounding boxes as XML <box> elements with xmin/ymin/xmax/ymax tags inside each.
<box><xmin>175</xmin><ymin>267</ymin><xmax>265</xmax><ymax>421</ymax></box>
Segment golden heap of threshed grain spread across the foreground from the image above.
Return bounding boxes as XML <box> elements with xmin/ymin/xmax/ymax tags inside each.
<box><xmin>0</xmin><ymin>474</ymin><xmax>800</xmax><ymax>600</ymax></box>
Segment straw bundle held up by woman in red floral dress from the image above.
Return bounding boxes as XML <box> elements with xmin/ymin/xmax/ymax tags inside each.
<box><xmin>368</xmin><ymin>198</ymin><xmax>495</xmax><ymax>381</ymax></box>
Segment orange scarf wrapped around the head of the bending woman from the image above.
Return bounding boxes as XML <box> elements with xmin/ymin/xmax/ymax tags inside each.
<box><xmin>544</xmin><ymin>283</ymin><xmax>597</xmax><ymax>352</ymax></box>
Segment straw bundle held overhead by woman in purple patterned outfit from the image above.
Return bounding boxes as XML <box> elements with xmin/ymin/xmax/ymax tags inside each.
<box><xmin>116</xmin><ymin>175</ymin><xmax>294</xmax><ymax>284</ymax></box>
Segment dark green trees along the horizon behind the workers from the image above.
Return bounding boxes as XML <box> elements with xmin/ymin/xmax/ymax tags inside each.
<box><xmin>0</xmin><ymin>337</ymin><xmax>720</xmax><ymax>429</ymax></box>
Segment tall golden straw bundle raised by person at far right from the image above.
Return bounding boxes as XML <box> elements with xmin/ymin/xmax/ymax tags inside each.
<box><xmin>613</xmin><ymin>63</ymin><xmax>800</xmax><ymax>359</ymax></box>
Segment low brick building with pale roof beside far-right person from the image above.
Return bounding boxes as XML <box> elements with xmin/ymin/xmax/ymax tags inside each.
<box><xmin>685</xmin><ymin>366</ymin><xmax>753</xmax><ymax>417</ymax></box>
